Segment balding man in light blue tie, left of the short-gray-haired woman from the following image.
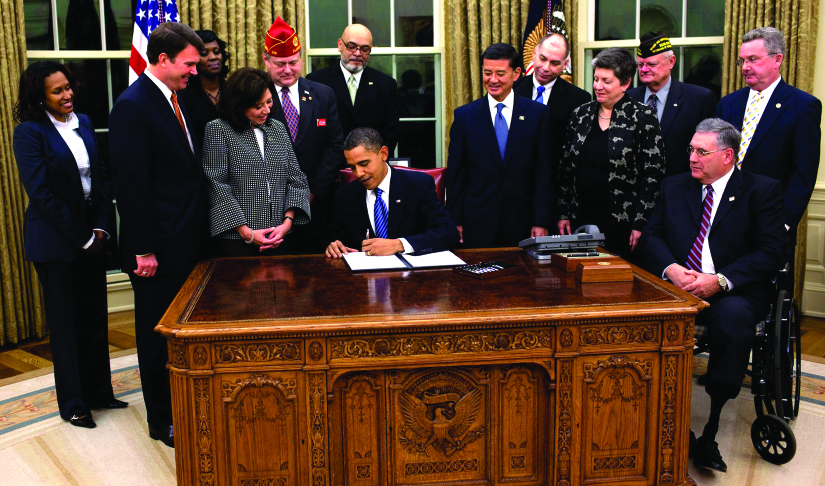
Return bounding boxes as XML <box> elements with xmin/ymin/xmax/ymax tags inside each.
<box><xmin>513</xmin><ymin>33</ymin><xmax>591</xmax><ymax>184</ymax></box>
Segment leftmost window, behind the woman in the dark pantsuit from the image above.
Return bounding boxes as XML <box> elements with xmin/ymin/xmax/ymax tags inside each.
<box><xmin>23</xmin><ymin>0</ymin><xmax>136</xmax><ymax>274</ymax></box>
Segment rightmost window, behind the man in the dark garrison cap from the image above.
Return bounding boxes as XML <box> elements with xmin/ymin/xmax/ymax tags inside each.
<box><xmin>577</xmin><ymin>0</ymin><xmax>725</xmax><ymax>97</ymax></box>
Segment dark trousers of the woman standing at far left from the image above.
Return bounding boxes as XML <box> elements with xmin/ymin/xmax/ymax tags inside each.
<box><xmin>34</xmin><ymin>252</ymin><xmax>114</xmax><ymax>420</ymax></box>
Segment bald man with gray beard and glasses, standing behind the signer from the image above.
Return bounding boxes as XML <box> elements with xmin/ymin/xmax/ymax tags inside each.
<box><xmin>307</xmin><ymin>24</ymin><xmax>399</xmax><ymax>157</ymax></box>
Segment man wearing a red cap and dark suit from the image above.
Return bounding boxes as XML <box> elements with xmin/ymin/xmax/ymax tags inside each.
<box><xmin>263</xmin><ymin>17</ymin><xmax>346</xmax><ymax>253</ymax></box>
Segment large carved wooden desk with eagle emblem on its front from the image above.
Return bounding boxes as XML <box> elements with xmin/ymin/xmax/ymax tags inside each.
<box><xmin>157</xmin><ymin>250</ymin><xmax>706</xmax><ymax>486</ymax></box>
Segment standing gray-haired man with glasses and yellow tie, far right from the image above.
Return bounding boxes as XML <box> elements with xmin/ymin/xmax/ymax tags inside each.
<box><xmin>716</xmin><ymin>27</ymin><xmax>822</xmax><ymax>292</ymax></box>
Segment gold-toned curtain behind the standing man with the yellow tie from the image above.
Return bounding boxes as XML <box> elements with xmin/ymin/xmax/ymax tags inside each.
<box><xmin>722</xmin><ymin>0</ymin><xmax>819</xmax><ymax>300</ymax></box>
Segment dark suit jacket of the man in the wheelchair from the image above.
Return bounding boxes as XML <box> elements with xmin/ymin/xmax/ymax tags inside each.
<box><xmin>639</xmin><ymin>169</ymin><xmax>788</xmax><ymax>299</ymax></box>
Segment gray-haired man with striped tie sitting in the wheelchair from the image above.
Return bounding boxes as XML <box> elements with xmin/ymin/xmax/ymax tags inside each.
<box><xmin>640</xmin><ymin>118</ymin><xmax>788</xmax><ymax>472</ymax></box>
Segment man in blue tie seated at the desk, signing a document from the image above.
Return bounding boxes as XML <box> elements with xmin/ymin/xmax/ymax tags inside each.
<box><xmin>326</xmin><ymin>128</ymin><xmax>459</xmax><ymax>258</ymax></box>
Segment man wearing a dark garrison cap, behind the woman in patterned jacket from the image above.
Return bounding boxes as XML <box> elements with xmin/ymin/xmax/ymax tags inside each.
<box><xmin>627</xmin><ymin>32</ymin><xmax>718</xmax><ymax>176</ymax></box>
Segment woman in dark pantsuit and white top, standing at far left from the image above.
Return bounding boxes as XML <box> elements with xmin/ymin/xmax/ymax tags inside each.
<box><xmin>13</xmin><ymin>61</ymin><xmax>127</xmax><ymax>428</ymax></box>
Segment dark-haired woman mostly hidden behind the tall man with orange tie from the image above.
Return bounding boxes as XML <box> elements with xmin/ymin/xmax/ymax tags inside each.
<box><xmin>178</xmin><ymin>30</ymin><xmax>230</xmax><ymax>141</ymax></box>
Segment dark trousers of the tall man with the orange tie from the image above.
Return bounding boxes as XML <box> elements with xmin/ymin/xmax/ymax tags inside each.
<box><xmin>129</xmin><ymin>272</ymin><xmax>189</xmax><ymax>427</ymax></box>
